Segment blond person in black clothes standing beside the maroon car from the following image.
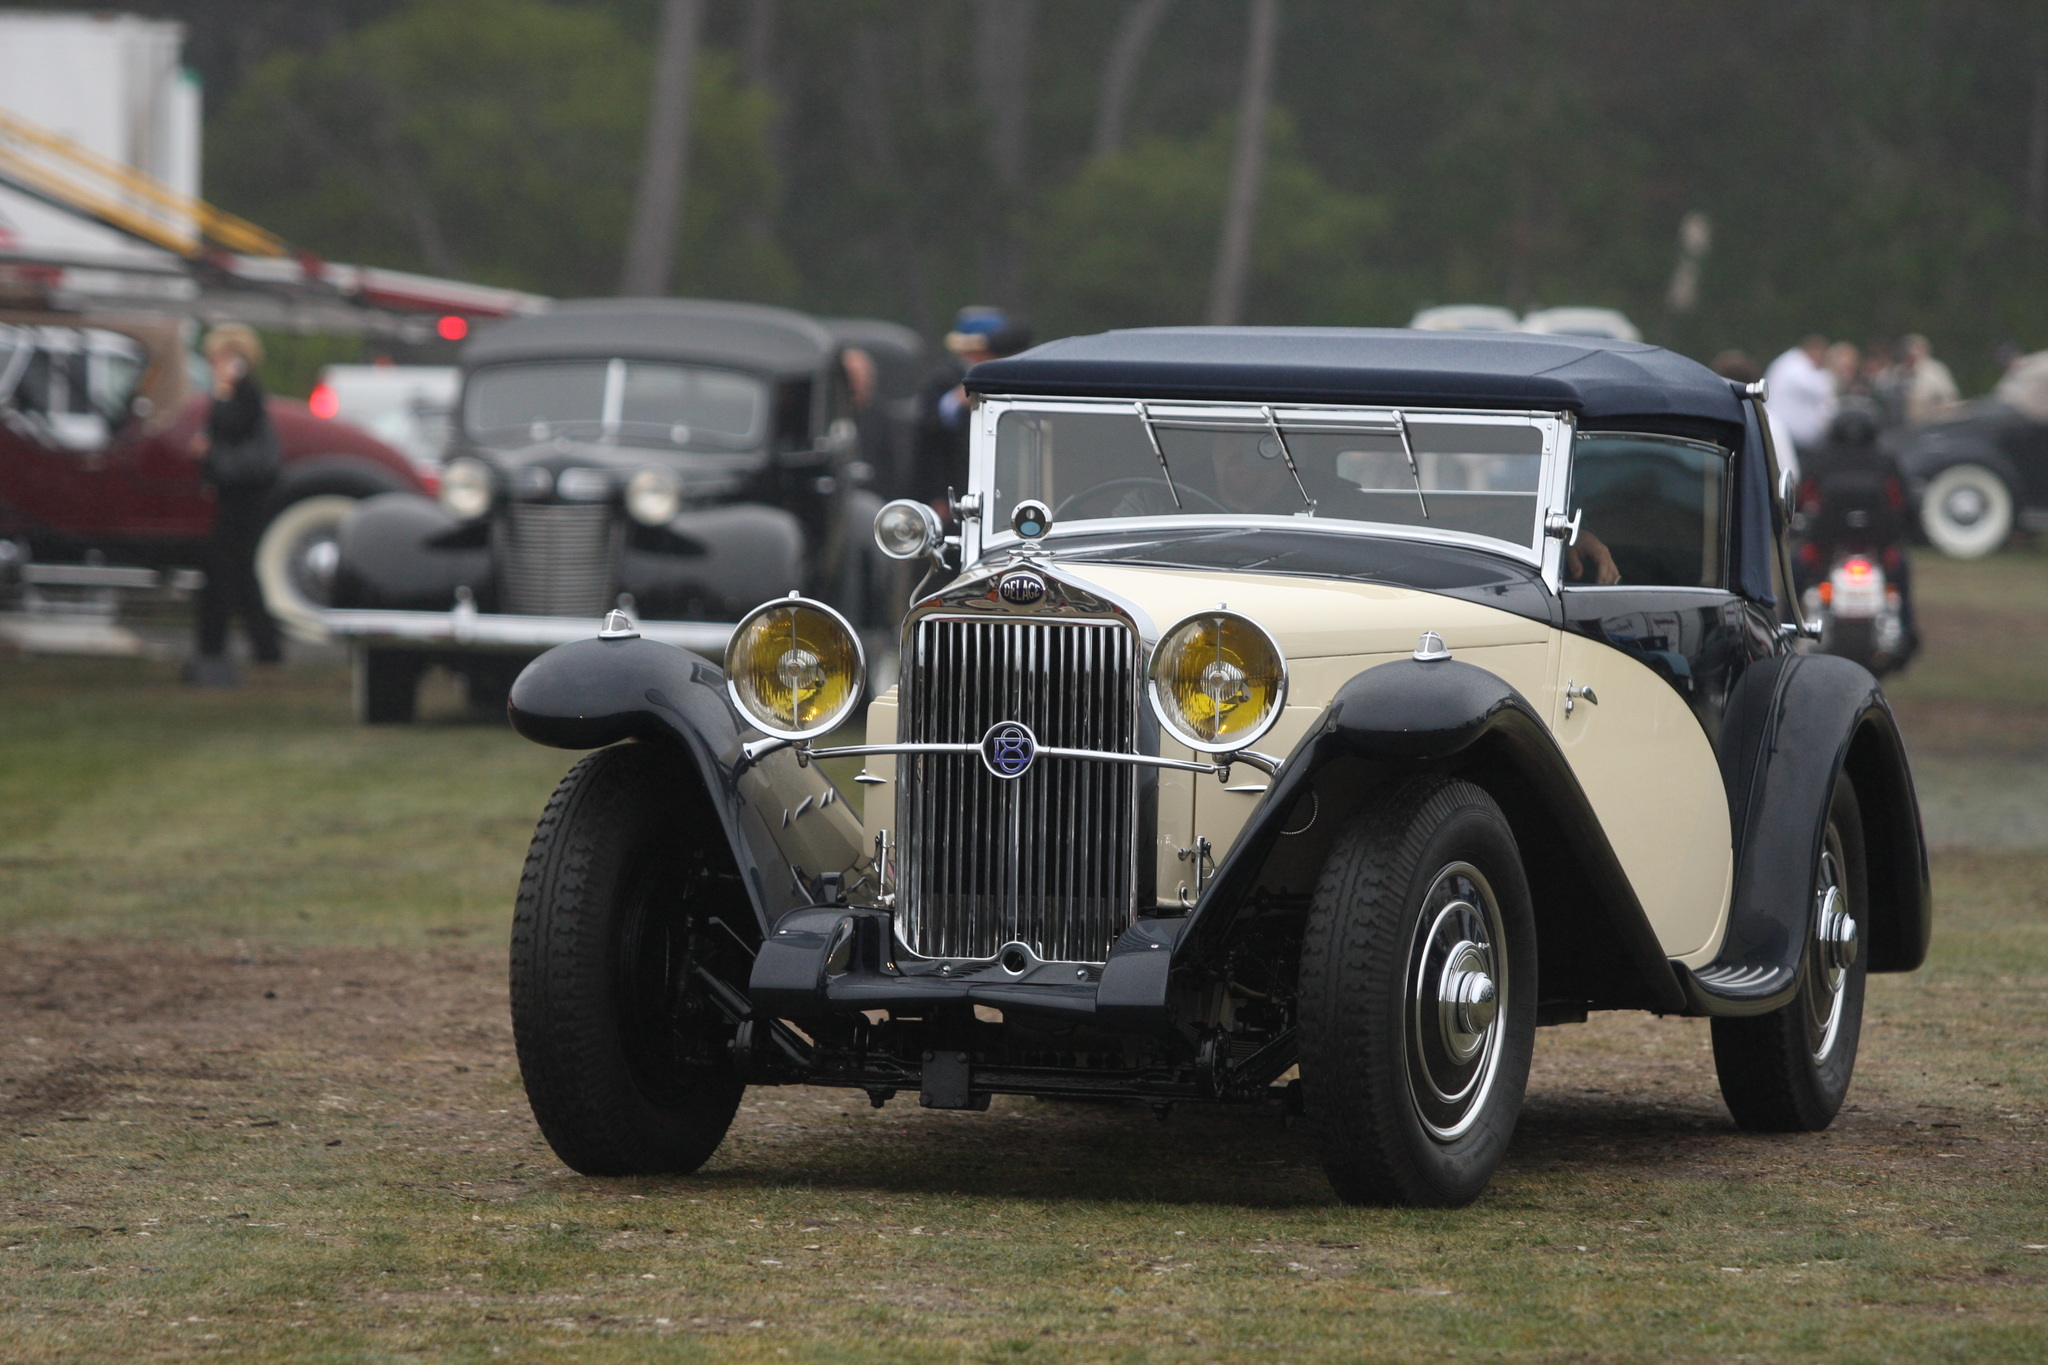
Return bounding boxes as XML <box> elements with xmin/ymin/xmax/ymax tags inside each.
<box><xmin>186</xmin><ymin>323</ymin><xmax>285</xmax><ymax>686</ymax></box>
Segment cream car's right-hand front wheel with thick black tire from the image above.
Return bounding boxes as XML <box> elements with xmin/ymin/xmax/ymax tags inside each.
<box><xmin>1300</xmin><ymin>776</ymin><xmax>1536</xmax><ymax>1207</ymax></box>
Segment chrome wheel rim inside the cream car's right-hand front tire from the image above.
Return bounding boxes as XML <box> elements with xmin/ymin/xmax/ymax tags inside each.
<box><xmin>1405</xmin><ymin>864</ymin><xmax>1507</xmax><ymax>1142</ymax></box>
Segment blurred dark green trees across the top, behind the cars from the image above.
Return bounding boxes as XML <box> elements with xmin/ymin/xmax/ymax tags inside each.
<box><xmin>16</xmin><ymin>0</ymin><xmax>2048</xmax><ymax>389</ymax></box>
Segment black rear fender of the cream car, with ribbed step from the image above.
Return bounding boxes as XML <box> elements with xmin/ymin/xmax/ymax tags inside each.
<box><xmin>1671</xmin><ymin>655</ymin><xmax>1933</xmax><ymax>1015</ymax></box>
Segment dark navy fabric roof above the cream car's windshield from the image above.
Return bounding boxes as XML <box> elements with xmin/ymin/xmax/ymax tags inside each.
<box><xmin>967</xmin><ymin>327</ymin><xmax>1743</xmax><ymax>430</ymax></box>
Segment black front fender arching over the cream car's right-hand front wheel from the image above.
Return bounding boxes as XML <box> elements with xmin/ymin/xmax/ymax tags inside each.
<box><xmin>1100</xmin><ymin>659</ymin><xmax>1686</xmax><ymax>1031</ymax></box>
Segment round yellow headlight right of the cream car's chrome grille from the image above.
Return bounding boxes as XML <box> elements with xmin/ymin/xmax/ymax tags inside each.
<box><xmin>1147</xmin><ymin>610</ymin><xmax>1286</xmax><ymax>753</ymax></box>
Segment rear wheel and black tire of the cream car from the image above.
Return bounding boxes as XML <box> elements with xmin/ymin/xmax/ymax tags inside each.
<box><xmin>1714</xmin><ymin>774</ymin><xmax>1870</xmax><ymax>1134</ymax></box>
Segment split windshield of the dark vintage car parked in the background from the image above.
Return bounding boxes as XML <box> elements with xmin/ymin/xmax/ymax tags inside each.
<box><xmin>463</xmin><ymin>360</ymin><xmax>768</xmax><ymax>450</ymax></box>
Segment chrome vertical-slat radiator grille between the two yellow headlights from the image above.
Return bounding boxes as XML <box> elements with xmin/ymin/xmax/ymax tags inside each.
<box><xmin>897</xmin><ymin>618</ymin><xmax>1139</xmax><ymax>962</ymax></box>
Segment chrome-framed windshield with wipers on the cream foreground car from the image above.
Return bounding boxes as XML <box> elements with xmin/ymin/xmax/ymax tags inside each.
<box><xmin>995</xmin><ymin>405</ymin><xmax>1544</xmax><ymax>548</ymax></box>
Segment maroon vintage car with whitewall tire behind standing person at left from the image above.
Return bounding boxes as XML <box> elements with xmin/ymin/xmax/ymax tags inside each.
<box><xmin>0</xmin><ymin>313</ymin><xmax>430</xmax><ymax>639</ymax></box>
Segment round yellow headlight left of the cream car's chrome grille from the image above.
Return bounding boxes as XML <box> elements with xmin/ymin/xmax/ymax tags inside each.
<box><xmin>725</xmin><ymin>596</ymin><xmax>866</xmax><ymax>739</ymax></box>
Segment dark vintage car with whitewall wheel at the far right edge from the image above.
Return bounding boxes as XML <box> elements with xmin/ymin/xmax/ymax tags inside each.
<box><xmin>1892</xmin><ymin>352</ymin><xmax>2048</xmax><ymax>559</ymax></box>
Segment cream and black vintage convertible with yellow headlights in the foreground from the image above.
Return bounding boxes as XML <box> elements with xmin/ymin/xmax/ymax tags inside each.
<box><xmin>510</xmin><ymin>329</ymin><xmax>1929</xmax><ymax>1205</ymax></box>
